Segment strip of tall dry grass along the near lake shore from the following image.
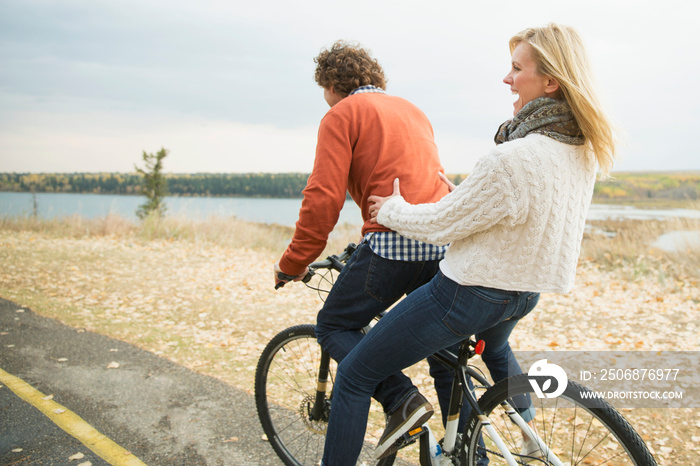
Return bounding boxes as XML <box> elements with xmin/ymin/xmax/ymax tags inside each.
<box><xmin>0</xmin><ymin>211</ymin><xmax>700</xmax><ymax>280</ymax></box>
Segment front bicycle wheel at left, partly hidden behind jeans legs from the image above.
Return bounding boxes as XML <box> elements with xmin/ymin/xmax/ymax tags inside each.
<box><xmin>255</xmin><ymin>325</ymin><xmax>395</xmax><ymax>466</ymax></box>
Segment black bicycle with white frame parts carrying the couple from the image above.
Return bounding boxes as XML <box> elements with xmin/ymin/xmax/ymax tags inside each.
<box><xmin>255</xmin><ymin>244</ymin><xmax>656</xmax><ymax>466</ymax></box>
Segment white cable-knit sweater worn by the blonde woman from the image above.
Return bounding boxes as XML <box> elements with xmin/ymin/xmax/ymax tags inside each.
<box><xmin>377</xmin><ymin>134</ymin><xmax>597</xmax><ymax>293</ymax></box>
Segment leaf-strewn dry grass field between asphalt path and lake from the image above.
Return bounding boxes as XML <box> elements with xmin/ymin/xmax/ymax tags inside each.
<box><xmin>0</xmin><ymin>218</ymin><xmax>700</xmax><ymax>464</ymax></box>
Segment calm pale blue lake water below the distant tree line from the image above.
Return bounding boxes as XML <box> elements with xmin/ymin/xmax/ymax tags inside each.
<box><xmin>0</xmin><ymin>192</ymin><xmax>700</xmax><ymax>226</ymax></box>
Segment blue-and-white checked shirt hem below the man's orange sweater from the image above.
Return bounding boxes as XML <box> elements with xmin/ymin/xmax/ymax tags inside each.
<box><xmin>364</xmin><ymin>231</ymin><xmax>447</xmax><ymax>262</ymax></box>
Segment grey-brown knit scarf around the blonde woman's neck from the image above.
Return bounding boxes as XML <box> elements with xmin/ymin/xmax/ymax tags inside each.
<box><xmin>494</xmin><ymin>97</ymin><xmax>585</xmax><ymax>146</ymax></box>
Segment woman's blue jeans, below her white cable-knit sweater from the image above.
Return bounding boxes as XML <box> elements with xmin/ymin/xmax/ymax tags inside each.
<box><xmin>323</xmin><ymin>272</ymin><xmax>539</xmax><ymax>466</ymax></box>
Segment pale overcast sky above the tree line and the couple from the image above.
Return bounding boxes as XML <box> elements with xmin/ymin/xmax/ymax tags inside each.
<box><xmin>0</xmin><ymin>0</ymin><xmax>700</xmax><ymax>173</ymax></box>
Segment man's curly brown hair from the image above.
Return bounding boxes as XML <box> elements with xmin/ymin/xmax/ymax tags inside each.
<box><xmin>314</xmin><ymin>41</ymin><xmax>386</xmax><ymax>97</ymax></box>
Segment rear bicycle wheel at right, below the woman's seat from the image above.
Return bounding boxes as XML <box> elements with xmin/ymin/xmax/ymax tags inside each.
<box><xmin>465</xmin><ymin>374</ymin><xmax>656</xmax><ymax>466</ymax></box>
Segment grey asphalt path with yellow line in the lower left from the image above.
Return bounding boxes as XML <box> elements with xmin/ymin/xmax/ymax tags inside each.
<box><xmin>0</xmin><ymin>298</ymin><xmax>281</xmax><ymax>466</ymax></box>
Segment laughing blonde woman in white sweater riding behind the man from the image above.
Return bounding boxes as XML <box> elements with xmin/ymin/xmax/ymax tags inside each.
<box><xmin>323</xmin><ymin>24</ymin><xmax>615</xmax><ymax>466</ymax></box>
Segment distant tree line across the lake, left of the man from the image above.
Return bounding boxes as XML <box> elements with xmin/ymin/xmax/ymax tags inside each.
<box><xmin>0</xmin><ymin>173</ymin><xmax>309</xmax><ymax>198</ymax></box>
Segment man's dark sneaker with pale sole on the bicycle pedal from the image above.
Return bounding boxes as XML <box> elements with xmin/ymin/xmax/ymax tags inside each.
<box><xmin>374</xmin><ymin>391</ymin><xmax>434</xmax><ymax>459</ymax></box>
